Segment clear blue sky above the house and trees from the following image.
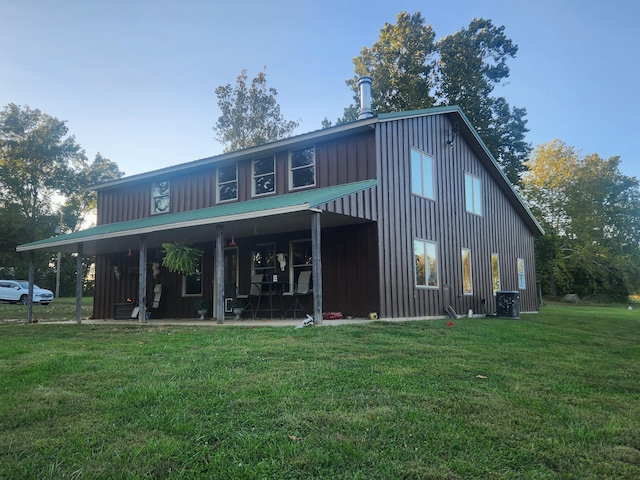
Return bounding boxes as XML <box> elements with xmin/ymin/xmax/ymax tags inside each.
<box><xmin>0</xmin><ymin>0</ymin><xmax>640</xmax><ymax>179</ymax></box>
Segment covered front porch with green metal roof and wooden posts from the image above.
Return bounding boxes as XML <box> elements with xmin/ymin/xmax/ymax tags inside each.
<box><xmin>18</xmin><ymin>180</ymin><xmax>377</xmax><ymax>325</ymax></box>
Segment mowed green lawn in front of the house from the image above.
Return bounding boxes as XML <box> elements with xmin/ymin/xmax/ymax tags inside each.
<box><xmin>0</xmin><ymin>305</ymin><xmax>640</xmax><ymax>479</ymax></box>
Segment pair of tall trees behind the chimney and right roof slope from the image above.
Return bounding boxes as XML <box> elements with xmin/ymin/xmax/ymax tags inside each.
<box><xmin>344</xmin><ymin>12</ymin><xmax>531</xmax><ymax>184</ymax></box>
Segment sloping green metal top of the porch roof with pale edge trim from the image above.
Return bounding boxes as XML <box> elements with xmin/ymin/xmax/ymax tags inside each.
<box><xmin>16</xmin><ymin>179</ymin><xmax>378</xmax><ymax>252</ymax></box>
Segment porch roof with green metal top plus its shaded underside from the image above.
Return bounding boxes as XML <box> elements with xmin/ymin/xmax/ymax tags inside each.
<box><xmin>16</xmin><ymin>180</ymin><xmax>377</xmax><ymax>255</ymax></box>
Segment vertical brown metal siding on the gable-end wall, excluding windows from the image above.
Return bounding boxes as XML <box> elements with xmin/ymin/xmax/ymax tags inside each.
<box><xmin>377</xmin><ymin>116</ymin><xmax>538</xmax><ymax>317</ymax></box>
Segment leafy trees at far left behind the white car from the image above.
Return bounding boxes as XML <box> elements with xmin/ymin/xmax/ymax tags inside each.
<box><xmin>0</xmin><ymin>103</ymin><xmax>123</xmax><ymax>296</ymax></box>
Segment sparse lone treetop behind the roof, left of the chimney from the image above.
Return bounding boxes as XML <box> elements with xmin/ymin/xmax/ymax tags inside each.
<box><xmin>213</xmin><ymin>67</ymin><xmax>298</xmax><ymax>152</ymax></box>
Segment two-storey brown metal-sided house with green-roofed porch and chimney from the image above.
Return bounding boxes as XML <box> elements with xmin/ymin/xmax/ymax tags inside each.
<box><xmin>18</xmin><ymin>78</ymin><xmax>544</xmax><ymax>323</ymax></box>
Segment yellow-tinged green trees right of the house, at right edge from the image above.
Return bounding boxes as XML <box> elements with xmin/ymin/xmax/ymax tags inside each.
<box><xmin>522</xmin><ymin>140</ymin><xmax>640</xmax><ymax>301</ymax></box>
